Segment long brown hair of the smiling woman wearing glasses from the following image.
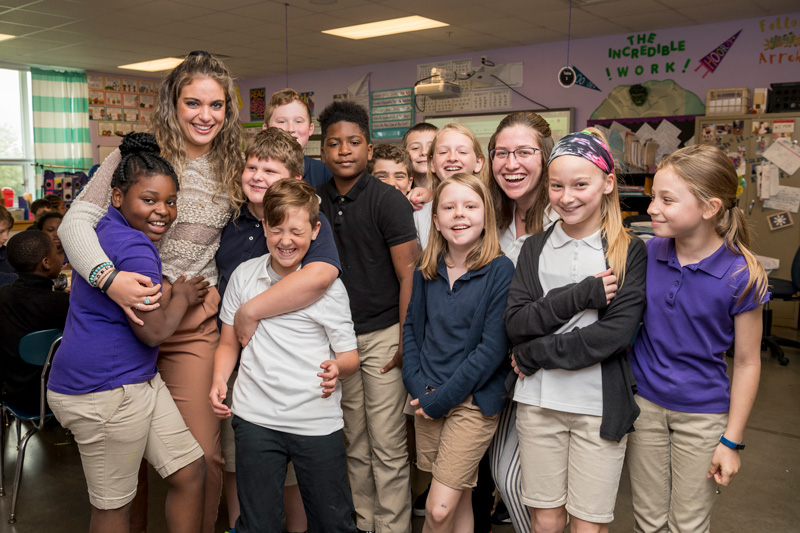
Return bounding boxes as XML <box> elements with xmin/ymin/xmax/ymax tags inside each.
<box><xmin>489</xmin><ymin>111</ymin><xmax>553</xmax><ymax>234</ymax></box>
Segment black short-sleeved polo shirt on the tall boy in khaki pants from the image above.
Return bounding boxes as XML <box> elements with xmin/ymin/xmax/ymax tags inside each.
<box><xmin>317</xmin><ymin>172</ymin><xmax>417</xmax><ymax>335</ymax></box>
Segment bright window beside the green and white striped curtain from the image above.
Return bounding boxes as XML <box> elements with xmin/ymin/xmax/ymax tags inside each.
<box><xmin>0</xmin><ymin>69</ymin><xmax>36</xmax><ymax>198</ymax></box>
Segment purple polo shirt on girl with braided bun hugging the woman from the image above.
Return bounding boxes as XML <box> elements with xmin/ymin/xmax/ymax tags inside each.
<box><xmin>47</xmin><ymin>206</ymin><xmax>161</xmax><ymax>394</ymax></box>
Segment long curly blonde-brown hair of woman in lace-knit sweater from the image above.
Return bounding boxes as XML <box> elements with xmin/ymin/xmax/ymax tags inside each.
<box><xmin>152</xmin><ymin>51</ymin><xmax>244</xmax><ymax>202</ymax></box>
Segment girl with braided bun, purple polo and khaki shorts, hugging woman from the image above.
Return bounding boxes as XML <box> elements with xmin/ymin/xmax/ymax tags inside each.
<box><xmin>47</xmin><ymin>133</ymin><xmax>208</xmax><ymax>533</ymax></box>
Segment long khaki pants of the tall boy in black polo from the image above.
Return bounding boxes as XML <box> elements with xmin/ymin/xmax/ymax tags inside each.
<box><xmin>341</xmin><ymin>324</ymin><xmax>411</xmax><ymax>533</ymax></box>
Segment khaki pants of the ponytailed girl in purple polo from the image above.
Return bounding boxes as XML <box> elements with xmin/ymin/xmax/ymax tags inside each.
<box><xmin>627</xmin><ymin>396</ymin><xmax>728</xmax><ymax>533</ymax></box>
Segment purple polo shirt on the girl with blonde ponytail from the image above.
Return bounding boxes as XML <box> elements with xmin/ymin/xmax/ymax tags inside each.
<box><xmin>630</xmin><ymin>237</ymin><xmax>769</xmax><ymax>413</ymax></box>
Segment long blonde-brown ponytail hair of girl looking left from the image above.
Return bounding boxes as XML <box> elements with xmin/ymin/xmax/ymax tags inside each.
<box><xmin>658</xmin><ymin>145</ymin><xmax>768</xmax><ymax>303</ymax></box>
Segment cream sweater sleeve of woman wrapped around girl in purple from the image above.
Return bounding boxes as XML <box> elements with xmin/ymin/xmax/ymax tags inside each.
<box><xmin>58</xmin><ymin>150</ymin><xmax>121</xmax><ymax>280</ymax></box>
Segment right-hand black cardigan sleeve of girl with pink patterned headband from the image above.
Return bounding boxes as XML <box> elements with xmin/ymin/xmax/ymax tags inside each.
<box><xmin>514</xmin><ymin>238</ymin><xmax>647</xmax><ymax>375</ymax></box>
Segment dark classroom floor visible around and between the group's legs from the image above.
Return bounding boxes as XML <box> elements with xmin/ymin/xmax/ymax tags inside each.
<box><xmin>0</xmin><ymin>328</ymin><xmax>800</xmax><ymax>533</ymax></box>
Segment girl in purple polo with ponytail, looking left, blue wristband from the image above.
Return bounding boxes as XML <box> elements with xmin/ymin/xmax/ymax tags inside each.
<box><xmin>627</xmin><ymin>145</ymin><xmax>769</xmax><ymax>532</ymax></box>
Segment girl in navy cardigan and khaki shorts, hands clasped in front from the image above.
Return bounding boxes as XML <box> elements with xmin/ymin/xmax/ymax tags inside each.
<box><xmin>403</xmin><ymin>173</ymin><xmax>514</xmax><ymax>531</ymax></box>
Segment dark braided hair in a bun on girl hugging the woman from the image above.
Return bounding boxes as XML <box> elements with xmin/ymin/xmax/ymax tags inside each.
<box><xmin>111</xmin><ymin>132</ymin><xmax>180</xmax><ymax>193</ymax></box>
